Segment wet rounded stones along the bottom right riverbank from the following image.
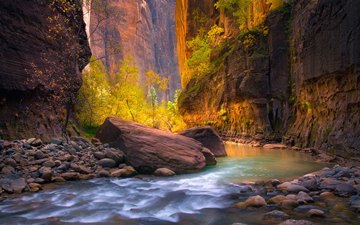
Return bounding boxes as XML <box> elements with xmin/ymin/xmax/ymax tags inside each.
<box><xmin>233</xmin><ymin>165</ymin><xmax>360</xmax><ymax>225</ymax></box>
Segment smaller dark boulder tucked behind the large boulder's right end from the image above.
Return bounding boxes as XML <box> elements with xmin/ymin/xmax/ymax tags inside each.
<box><xmin>180</xmin><ymin>126</ymin><xmax>227</xmax><ymax>157</ymax></box>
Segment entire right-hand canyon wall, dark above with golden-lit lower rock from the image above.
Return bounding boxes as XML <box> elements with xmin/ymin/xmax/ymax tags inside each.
<box><xmin>178</xmin><ymin>0</ymin><xmax>360</xmax><ymax>156</ymax></box>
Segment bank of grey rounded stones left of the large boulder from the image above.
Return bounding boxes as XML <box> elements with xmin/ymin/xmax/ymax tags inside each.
<box><xmin>0</xmin><ymin>137</ymin><xmax>144</xmax><ymax>196</ymax></box>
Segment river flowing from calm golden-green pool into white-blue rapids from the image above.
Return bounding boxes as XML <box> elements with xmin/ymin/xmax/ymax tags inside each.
<box><xmin>0</xmin><ymin>144</ymin><xmax>352</xmax><ymax>225</ymax></box>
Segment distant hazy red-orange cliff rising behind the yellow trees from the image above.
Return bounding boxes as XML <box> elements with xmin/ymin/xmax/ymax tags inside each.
<box><xmin>90</xmin><ymin>0</ymin><xmax>180</xmax><ymax>96</ymax></box>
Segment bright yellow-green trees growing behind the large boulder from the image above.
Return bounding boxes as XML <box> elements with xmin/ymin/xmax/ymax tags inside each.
<box><xmin>76</xmin><ymin>56</ymin><xmax>185</xmax><ymax>132</ymax></box>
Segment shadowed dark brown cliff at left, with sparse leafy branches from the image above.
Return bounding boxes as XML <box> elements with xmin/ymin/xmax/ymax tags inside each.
<box><xmin>0</xmin><ymin>0</ymin><xmax>90</xmax><ymax>140</ymax></box>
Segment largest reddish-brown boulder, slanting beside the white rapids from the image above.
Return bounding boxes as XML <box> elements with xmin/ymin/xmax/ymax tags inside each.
<box><xmin>96</xmin><ymin>117</ymin><xmax>210</xmax><ymax>173</ymax></box>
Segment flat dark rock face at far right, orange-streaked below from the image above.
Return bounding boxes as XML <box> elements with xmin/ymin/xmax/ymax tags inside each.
<box><xmin>288</xmin><ymin>0</ymin><xmax>360</xmax><ymax>156</ymax></box>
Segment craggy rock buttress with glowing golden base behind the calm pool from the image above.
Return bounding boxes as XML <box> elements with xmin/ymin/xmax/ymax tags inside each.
<box><xmin>180</xmin><ymin>7</ymin><xmax>289</xmax><ymax>135</ymax></box>
